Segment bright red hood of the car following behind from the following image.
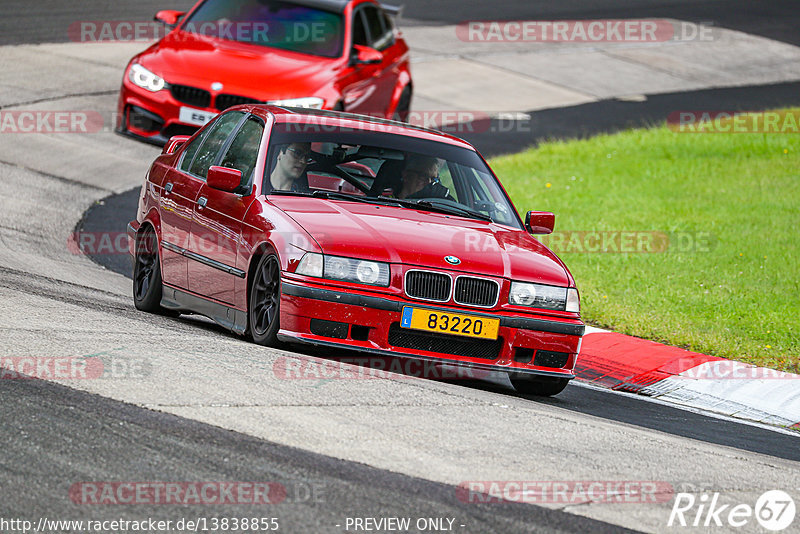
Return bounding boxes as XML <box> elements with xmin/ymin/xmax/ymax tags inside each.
<box><xmin>137</xmin><ymin>32</ymin><xmax>339</xmax><ymax>100</ymax></box>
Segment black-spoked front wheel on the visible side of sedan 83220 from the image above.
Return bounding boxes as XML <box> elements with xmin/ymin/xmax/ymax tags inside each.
<box><xmin>247</xmin><ymin>254</ymin><xmax>281</xmax><ymax>346</ymax></box>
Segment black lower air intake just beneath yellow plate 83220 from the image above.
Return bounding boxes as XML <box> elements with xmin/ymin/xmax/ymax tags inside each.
<box><xmin>389</xmin><ymin>323</ymin><xmax>503</xmax><ymax>360</ymax></box>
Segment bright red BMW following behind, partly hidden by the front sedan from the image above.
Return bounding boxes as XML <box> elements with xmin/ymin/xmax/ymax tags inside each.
<box><xmin>117</xmin><ymin>0</ymin><xmax>412</xmax><ymax>145</ymax></box>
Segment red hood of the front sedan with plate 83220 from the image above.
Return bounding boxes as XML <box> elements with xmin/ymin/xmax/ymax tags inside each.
<box><xmin>270</xmin><ymin>196</ymin><xmax>570</xmax><ymax>287</ymax></box>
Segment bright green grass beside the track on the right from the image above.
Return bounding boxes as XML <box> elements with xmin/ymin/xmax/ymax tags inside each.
<box><xmin>491</xmin><ymin>115</ymin><xmax>800</xmax><ymax>372</ymax></box>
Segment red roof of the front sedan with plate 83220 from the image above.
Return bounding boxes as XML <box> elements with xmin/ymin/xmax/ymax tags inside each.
<box><xmin>245</xmin><ymin>104</ymin><xmax>477</xmax><ymax>152</ymax></box>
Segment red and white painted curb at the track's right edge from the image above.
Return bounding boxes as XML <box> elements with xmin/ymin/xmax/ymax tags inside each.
<box><xmin>575</xmin><ymin>326</ymin><xmax>800</xmax><ymax>430</ymax></box>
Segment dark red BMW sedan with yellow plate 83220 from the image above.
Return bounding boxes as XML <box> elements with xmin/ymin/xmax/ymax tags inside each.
<box><xmin>128</xmin><ymin>105</ymin><xmax>584</xmax><ymax>395</ymax></box>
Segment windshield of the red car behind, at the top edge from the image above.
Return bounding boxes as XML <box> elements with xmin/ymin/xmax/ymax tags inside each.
<box><xmin>181</xmin><ymin>0</ymin><xmax>344</xmax><ymax>57</ymax></box>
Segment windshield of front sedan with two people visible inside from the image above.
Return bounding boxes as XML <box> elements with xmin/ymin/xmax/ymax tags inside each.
<box><xmin>262</xmin><ymin>124</ymin><xmax>521</xmax><ymax>228</ymax></box>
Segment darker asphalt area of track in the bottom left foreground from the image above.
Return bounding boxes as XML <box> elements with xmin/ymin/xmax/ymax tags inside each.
<box><xmin>0</xmin><ymin>380</ymin><xmax>633</xmax><ymax>534</ymax></box>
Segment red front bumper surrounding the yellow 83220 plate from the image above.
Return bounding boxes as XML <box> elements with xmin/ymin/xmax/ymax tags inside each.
<box><xmin>278</xmin><ymin>280</ymin><xmax>584</xmax><ymax>379</ymax></box>
